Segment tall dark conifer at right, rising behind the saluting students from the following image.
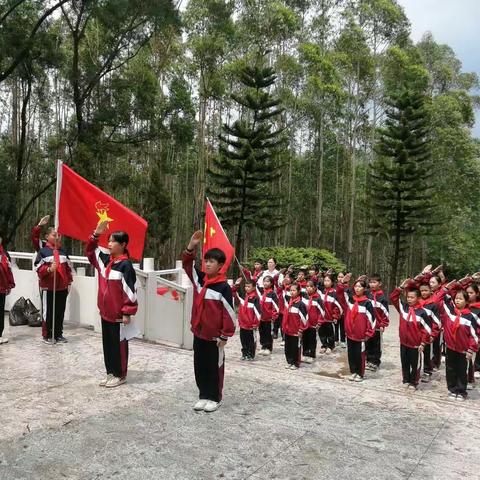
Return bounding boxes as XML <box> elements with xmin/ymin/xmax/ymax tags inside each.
<box><xmin>370</xmin><ymin>86</ymin><xmax>434</xmax><ymax>286</ymax></box>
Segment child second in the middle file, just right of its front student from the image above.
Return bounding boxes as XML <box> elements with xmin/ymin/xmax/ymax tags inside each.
<box><xmin>302</xmin><ymin>280</ymin><xmax>325</xmax><ymax>363</ymax></box>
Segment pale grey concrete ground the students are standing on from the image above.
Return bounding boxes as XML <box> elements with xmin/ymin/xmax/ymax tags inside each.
<box><xmin>0</xmin><ymin>312</ymin><xmax>480</xmax><ymax>480</ymax></box>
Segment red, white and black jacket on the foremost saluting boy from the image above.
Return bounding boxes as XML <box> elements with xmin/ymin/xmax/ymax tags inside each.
<box><xmin>182</xmin><ymin>251</ymin><xmax>235</xmax><ymax>341</ymax></box>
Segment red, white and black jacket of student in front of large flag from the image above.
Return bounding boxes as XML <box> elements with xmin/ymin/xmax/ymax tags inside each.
<box><xmin>86</xmin><ymin>236</ymin><xmax>138</xmax><ymax>323</ymax></box>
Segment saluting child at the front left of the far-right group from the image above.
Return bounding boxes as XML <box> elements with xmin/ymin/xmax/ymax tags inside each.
<box><xmin>390</xmin><ymin>280</ymin><xmax>432</xmax><ymax>390</ymax></box>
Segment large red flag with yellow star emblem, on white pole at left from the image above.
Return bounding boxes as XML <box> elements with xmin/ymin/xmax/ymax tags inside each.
<box><xmin>56</xmin><ymin>162</ymin><xmax>148</xmax><ymax>260</ymax></box>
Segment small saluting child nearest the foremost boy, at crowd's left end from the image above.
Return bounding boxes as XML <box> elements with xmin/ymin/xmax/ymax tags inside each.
<box><xmin>232</xmin><ymin>278</ymin><xmax>262</xmax><ymax>360</ymax></box>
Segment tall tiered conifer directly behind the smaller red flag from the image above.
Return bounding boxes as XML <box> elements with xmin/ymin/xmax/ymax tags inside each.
<box><xmin>207</xmin><ymin>57</ymin><xmax>286</xmax><ymax>256</ymax></box>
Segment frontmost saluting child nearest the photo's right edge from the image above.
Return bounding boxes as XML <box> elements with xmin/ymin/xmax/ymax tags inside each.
<box><xmin>440</xmin><ymin>282</ymin><xmax>478</xmax><ymax>400</ymax></box>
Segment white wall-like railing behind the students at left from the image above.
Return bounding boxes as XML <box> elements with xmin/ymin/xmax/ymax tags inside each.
<box><xmin>6</xmin><ymin>252</ymin><xmax>193</xmax><ymax>349</ymax></box>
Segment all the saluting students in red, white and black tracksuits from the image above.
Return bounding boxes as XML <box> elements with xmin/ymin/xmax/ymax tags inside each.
<box><xmin>0</xmin><ymin>225</ymin><xmax>480</xmax><ymax>412</ymax></box>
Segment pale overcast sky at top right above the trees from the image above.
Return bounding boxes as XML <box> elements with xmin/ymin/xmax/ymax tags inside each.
<box><xmin>397</xmin><ymin>0</ymin><xmax>480</xmax><ymax>137</ymax></box>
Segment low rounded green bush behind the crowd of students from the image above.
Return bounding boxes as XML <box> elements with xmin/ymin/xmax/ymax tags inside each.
<box><xmin>249</xmin><ymin>247</ymin><xmax>345</xmax><ymax>272</ymax></box>
